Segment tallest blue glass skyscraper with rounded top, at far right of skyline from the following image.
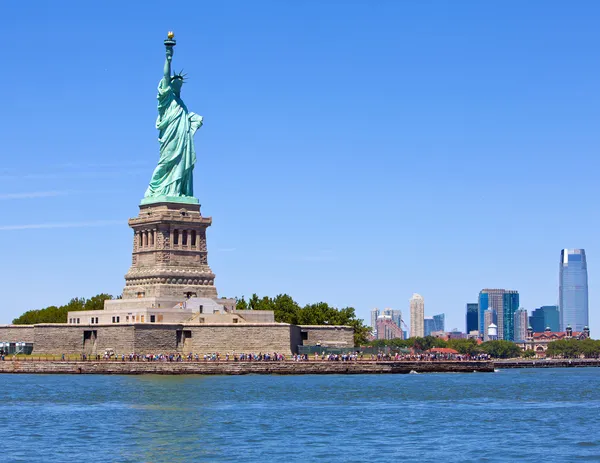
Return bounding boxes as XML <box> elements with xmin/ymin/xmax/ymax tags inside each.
<box><xmin>558</xmin><ymin>249</ymin><xmax>589</xmax><ymax>331</ymax></box>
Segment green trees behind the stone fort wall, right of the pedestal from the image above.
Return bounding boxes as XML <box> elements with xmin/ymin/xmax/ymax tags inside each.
<box><xmin>236</xmin><ymin>294</ymin><xmax>370</xmax><ymax>345</ymax></box>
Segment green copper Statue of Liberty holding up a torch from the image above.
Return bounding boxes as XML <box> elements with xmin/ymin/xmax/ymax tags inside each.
<box><xmin>142</xmin><ymin>32</ymin><xmax>202</xmax><ymax>204</ymax></box>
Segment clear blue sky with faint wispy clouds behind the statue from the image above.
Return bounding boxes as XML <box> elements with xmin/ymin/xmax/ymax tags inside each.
<box><xmin>0</xmin><ymin>0</ymin><xmax>600</xmax><ymax>337</ymax></box>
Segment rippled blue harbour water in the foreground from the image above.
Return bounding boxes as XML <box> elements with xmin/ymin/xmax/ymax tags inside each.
<box><xmin>0</xmin><ymin>368</ymin><xmax>600</xmax><ymax>463</ymax></box>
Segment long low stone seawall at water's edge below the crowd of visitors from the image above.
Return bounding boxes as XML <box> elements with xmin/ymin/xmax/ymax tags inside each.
<box><xmin>0</xmin><ymin>360</ymin><xmax>494</xmax><ymax>375</ymax></box>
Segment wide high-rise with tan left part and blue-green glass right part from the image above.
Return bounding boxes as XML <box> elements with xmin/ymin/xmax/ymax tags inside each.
<box><xmin>479</xmin><ymin>289</ymin><xmax>519</xmax><ymax>341</ymax></box>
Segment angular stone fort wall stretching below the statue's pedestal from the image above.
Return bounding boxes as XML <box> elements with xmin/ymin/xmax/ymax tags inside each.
<box><xmin>0</xmin><ymin>324</ymin><xmax>353</xmax><ymax>356</ymax></box>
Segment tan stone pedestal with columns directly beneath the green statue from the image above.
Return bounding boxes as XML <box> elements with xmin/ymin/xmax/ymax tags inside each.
<box><xmin>123</xmin><ymin>202</ymin><xmax>217</xmax><ymax>301</ymax></box>
